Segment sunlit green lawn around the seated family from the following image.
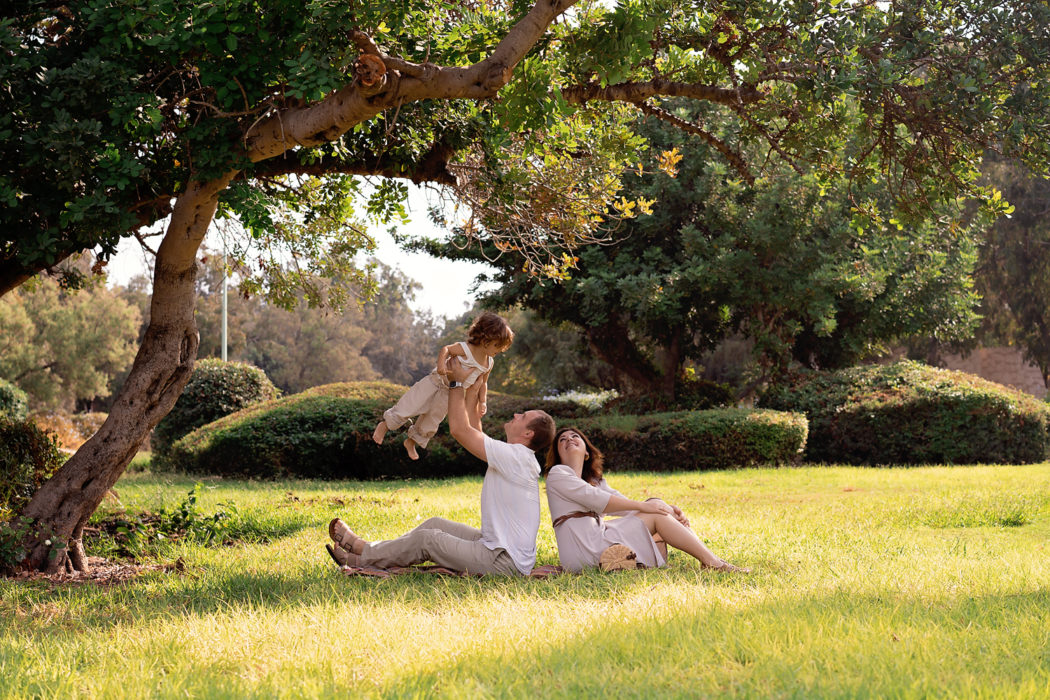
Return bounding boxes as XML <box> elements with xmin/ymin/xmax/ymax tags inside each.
<box><xmin>0</xmin><ymin>464</ymin><xmax>1050</xmax><ymax>698</ymax></box>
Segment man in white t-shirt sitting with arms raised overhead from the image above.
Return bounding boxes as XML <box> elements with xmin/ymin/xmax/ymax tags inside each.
<box><xmin>326</xmin><ymin>358</ymin><xmax>554</xmax><ymax>576</ymax></box>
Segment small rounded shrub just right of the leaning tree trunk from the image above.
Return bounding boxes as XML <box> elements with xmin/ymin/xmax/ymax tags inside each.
<box><xmin>152</xmin><ymin>359</ymin><xmax>279</xmax><ymax>457</ymax></box>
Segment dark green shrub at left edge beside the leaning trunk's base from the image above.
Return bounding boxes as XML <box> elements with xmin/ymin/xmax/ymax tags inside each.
<box><xmin>0</xmin><ymin>419</ymin><xmax>63</xmax><ymax>523</ymax></box>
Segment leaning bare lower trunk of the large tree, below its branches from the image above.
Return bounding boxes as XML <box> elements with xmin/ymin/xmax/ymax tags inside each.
<box><xmin>22</xmin><ymin>178</ymin><xmax>229</xmax><ymax>571</ymax></box>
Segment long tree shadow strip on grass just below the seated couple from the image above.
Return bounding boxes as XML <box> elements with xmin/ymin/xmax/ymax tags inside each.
<box><xmin>0</xmin><ymin>544</ymin><xmax>764</xmax><ymax>630</ymax></box>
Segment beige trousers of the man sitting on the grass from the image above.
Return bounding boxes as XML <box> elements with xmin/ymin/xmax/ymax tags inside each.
<box><xmin>361</xmin><ymin>517</ymin><xmax>521</xmax><ymax>576</ymax></box>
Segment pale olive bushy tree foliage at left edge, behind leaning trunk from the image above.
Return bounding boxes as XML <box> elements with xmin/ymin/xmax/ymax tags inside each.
<box><xmin>0</xmin><ymin>268</ymin><xmax>140</xmax><ymax>408</ymax></box>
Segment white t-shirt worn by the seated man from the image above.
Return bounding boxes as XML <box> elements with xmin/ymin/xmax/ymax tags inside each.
<box><xmin>481</xmin><ymin>436</ymin><xmax>540</xmax><ymax>576</ymax></box>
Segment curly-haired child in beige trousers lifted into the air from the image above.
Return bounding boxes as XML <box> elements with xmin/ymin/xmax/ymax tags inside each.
<box><xmin>372</xmin><ymin>311</ymin><xmax>515</xmax><ymax>460</ymax></box>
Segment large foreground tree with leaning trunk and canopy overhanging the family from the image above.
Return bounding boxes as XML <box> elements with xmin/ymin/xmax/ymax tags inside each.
<box><xmin>0</xmin><ymin>0</ymin><xmax>1050</xmax><ymax>569</ymax></box>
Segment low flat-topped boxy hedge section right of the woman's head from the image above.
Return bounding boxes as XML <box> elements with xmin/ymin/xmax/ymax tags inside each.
<box><xmin>575</xmin><ymin>408</ymin><xmax>807</xmax><ymax>471</ymax></box>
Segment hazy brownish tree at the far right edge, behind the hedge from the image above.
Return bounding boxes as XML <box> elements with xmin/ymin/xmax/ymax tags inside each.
<box><xmin>977</xmin><ymin>158</ymin><xmax>1050</xmax><ymax>388</ymax></box>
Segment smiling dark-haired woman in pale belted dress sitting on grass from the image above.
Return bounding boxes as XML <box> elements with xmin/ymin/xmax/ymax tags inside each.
<box><xmin>546</xmin><ymin>427</ymin><xmax>750</xmax><ymax>573</ymax></box>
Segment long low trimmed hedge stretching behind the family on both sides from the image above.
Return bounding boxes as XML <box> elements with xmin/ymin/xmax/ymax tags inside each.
<box><xmin>167</xmin><ymin>382</ymin><xmax>805</xmax><ymax>479</ymax></box>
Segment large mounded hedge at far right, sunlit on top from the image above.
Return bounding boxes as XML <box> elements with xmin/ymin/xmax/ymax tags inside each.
<box><xmin>760</xmin><ymin>360</ymin><xmax>1050</xmax><ymax>464</ymax></box>
